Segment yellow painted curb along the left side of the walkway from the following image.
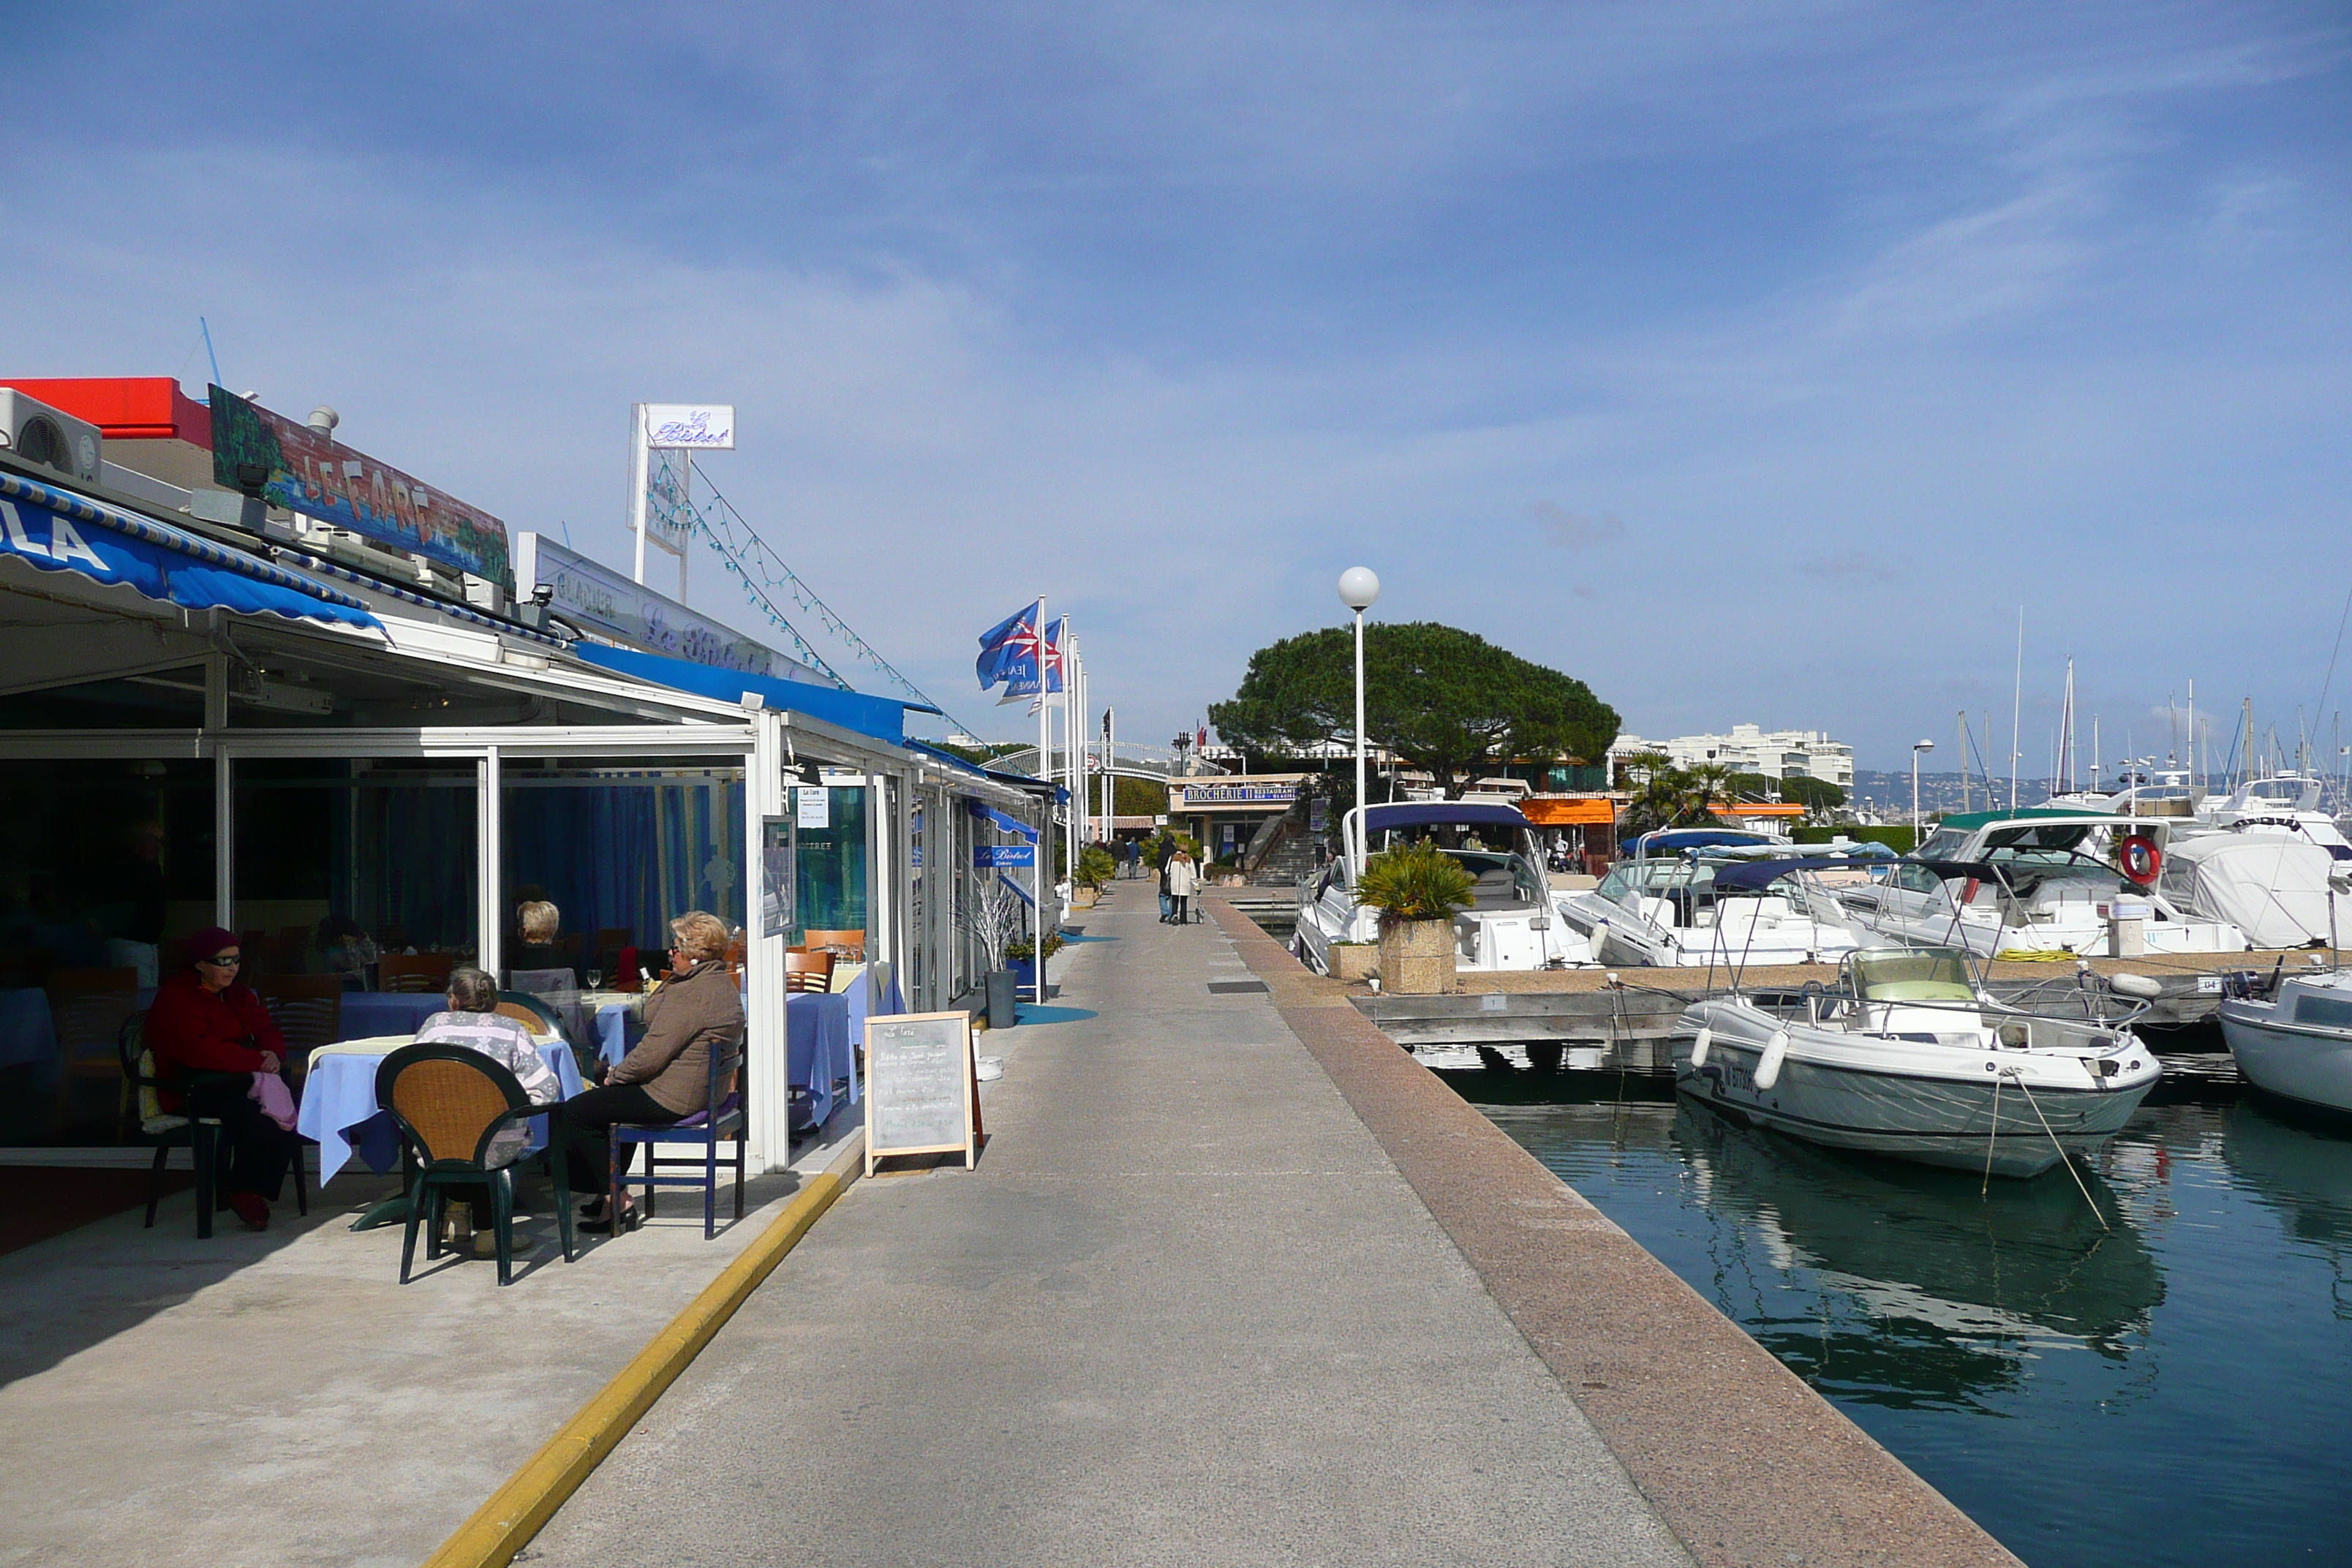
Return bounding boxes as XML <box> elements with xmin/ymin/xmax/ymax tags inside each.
<box><xmin>423</xmin><ymin>1128</ymin><xmax>865</xmax><ymax>1568</ymax></box>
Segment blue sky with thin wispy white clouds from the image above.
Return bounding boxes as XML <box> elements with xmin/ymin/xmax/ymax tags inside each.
<box><xmin>13</xmin><ymin>0</ymin><xmax>2352</xmax><ymax>774</ymax></box>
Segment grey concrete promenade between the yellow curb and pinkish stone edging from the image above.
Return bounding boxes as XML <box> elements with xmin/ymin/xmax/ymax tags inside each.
<box><xmin>527</xmin><ymin>884</ymin><xmax>1686</xmax><ymax>1568</ymax></box>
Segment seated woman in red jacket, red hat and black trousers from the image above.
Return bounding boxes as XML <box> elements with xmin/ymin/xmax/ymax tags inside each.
<box><xmin>146</xmin><ymin>926</ymin><xmax>298</xmax><ymax>1229</ymax></box>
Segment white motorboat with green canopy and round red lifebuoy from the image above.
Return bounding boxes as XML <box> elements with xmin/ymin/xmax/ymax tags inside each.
<box><xmin>1837</xmin><ymin>807</ymin><xmax>2246</xmax><ymax>957</ymax></box>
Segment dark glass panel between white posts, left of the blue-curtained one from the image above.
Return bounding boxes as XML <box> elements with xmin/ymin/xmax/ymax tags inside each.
<box><xmin>233</xmin><ymin>757</ymin><xmax>480</xmax><ymax>990</ymax></box>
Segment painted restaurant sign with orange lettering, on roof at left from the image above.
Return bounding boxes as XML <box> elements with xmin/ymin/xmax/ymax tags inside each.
<box><xmin>211</xmin><ymin>388</ymin><xmax>515</xmax><ymax>590</ymax></box>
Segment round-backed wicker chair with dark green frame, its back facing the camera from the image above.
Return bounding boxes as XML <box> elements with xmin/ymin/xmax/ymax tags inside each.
<box><xmin>377</xmin><ymin>1046</ymin><xmax>576</xmax><ymax>1286</ymax></box>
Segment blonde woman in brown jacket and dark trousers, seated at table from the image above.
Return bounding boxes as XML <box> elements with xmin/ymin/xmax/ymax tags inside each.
<box><xmin>565</xmin><ymin>910</ymin><xmax>743</xmax><ymax>1232</ymax></box>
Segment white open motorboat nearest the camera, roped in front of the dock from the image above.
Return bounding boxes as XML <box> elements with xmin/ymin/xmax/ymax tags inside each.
<box><xmin>1670</xmin><ymin>947</ymin><xmax>2162</xmax><ymax>1175</ymax></box>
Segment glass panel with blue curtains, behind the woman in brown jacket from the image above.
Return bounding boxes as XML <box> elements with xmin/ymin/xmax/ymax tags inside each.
<box><xmin>499</xmin><ymin>757</ymin><xmax>748</xmax><ymax>985</ymax></box>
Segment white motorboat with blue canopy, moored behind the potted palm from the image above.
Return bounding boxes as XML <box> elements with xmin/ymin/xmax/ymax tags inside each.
<box><xmin>1292</xmin><ymin>799</ymin><xmax>1592</xmax><ymax>973</ymax></box>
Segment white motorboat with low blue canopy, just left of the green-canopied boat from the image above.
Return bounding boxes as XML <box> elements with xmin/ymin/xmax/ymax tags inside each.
<box><xmin>1557</xmin><ymin>834</ymin><xmax>1870</xmax><ymax>968</ymax></box>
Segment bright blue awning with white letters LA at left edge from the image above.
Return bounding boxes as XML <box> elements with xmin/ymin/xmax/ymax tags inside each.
<box><xmin>0</xmin><ymin>472</ymin><xmax>383</xmax><ymax>630</ymax></box>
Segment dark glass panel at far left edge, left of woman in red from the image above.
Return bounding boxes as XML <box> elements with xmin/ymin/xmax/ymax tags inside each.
<box><xmin>0</xmin><ymin>759</ymin><xmax>211</xmax><ymax>1145</ymax></box>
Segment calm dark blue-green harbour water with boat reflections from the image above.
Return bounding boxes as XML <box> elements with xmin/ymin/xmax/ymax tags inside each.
<box><xmin>1425</xmin><ymin>1053</ymin><xmax>2352</xmax><ymax>1568</ymax></box>
